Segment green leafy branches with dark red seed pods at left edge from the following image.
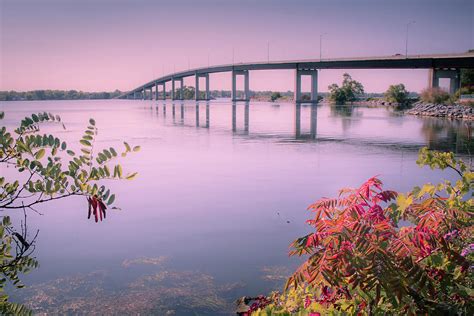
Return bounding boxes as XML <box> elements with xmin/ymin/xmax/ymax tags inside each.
<box><xmin>0</xmin><ymin>112</ymin><xmax>140</xmax><ymax>315</ymax></box>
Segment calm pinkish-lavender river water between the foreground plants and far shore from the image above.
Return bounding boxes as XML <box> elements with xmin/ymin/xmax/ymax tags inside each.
<box><xmin>1</xmin><ymin>100</ymin><xmax>474</xmax><ymax>315</ymax></box>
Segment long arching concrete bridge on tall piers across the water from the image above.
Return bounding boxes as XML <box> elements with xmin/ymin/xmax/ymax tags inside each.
<box><xmin>119</xmin><ymin>52</ymin><xmax>474</xmax><ymax>103</ymax></box>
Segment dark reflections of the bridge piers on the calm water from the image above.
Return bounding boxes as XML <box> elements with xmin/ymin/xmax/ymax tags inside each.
<box><xmin>151</xmin><ymin>101</ymin><xmax>318</xmax><ymax>140</ymax></box>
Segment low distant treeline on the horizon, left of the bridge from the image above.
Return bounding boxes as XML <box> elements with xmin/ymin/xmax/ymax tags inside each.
<box><xmin>0</xmin><ymin>90</ymin><xmax>122</xmax><ymax>101</ymax></box>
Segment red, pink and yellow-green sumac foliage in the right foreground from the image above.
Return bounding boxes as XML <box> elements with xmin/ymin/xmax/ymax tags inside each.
<box><xmin>250</xmin><ymin>148</ymin><xmax>474</xmax><ymax>315</ymax></box>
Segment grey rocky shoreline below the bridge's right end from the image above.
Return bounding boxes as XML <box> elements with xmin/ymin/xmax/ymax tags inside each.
<box><xmin>405</xmin><ymin>102</ymin><xmax>474</xmax><ymax>121</ymax></box>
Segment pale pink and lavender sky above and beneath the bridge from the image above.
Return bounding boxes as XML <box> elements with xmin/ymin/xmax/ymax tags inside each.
<box><xmin>0</xmin><ymin>0</ymin><xmax>474</xmax><ymax>92</ymax></box>
